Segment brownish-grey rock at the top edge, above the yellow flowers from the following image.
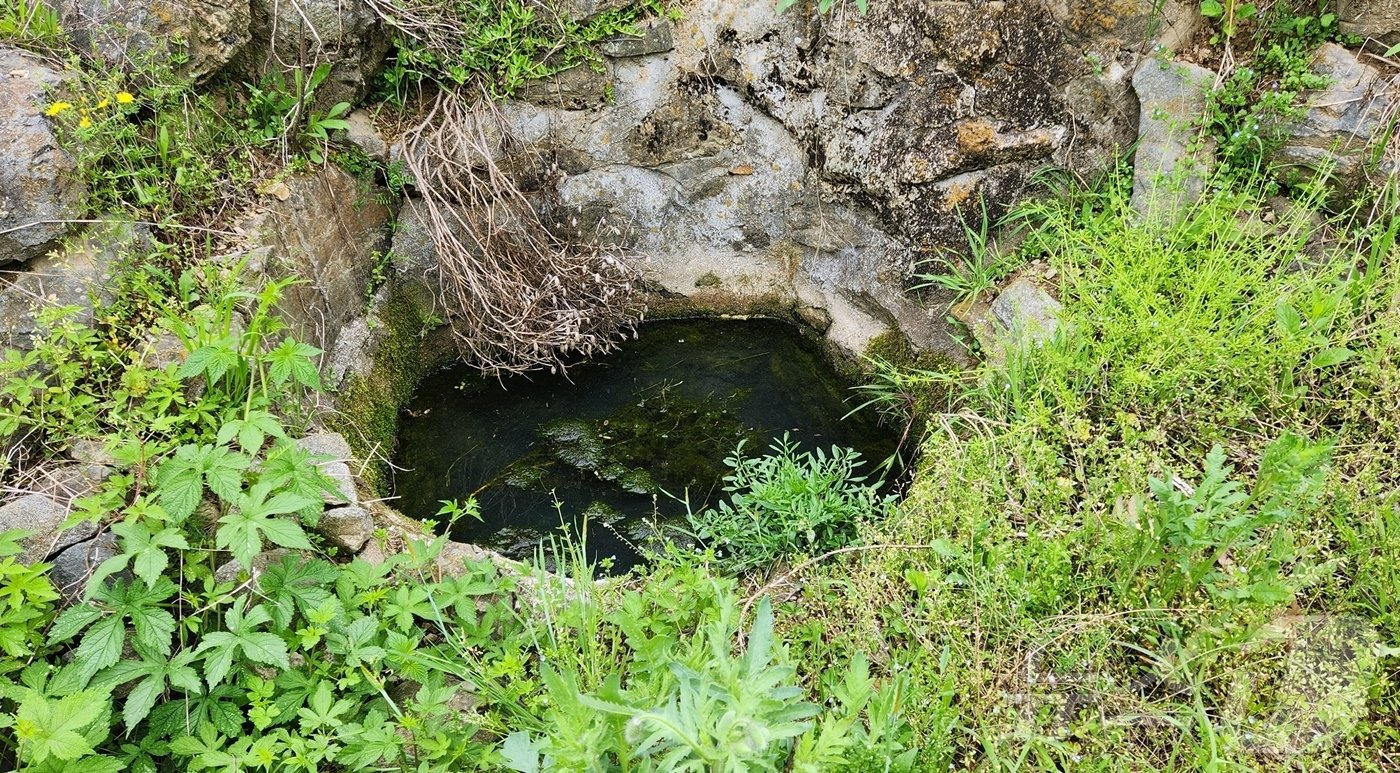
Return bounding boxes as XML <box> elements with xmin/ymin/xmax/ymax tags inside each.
<box><xmin>57</xmin><ymin>0</ymin><xmax>251</xmax><ymax>80</ymax></box>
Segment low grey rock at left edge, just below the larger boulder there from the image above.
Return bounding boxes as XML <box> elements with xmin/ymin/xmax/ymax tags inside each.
<box><xmin>0</xmin><ymin>218</ymin><xmax>146</xmax><ymax>349</ymax></box>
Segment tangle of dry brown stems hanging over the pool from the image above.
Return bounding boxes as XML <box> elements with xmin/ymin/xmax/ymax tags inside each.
<box><xmin>371</xmin><ymin>0</ymin><xmax>643</xmax><ymax>374</ymax></box>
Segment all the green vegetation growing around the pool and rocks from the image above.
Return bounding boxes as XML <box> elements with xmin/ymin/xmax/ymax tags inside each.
<box><xmin>0</xmin><ymin>0</ymin><xmax>1400</xmax><ymax>773</ymax></box>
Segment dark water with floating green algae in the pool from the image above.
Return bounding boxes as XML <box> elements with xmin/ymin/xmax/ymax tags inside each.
<box><xmin>395</xmin><ymin>319</ymin><xmax>897</xmax><ymax>570</ymax></box>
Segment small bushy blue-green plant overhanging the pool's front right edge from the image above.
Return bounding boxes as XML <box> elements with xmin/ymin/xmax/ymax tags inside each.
<box><xmin>689</xmin><ymin>436</ymin><xmax>892</xmax><ymax>571</ymax></box>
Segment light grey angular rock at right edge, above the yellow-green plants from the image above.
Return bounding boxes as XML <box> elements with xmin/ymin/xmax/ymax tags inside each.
<box><xmin>1273</xmin><ymin>43</ymin><xmax>1400</xmax><ymax>204</ymax></box>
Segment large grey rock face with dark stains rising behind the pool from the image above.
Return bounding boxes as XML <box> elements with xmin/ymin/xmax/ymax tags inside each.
<box><xmin>478</xmin><ymin>0</ymin><xmax>1181</xmax><ymax>357</ymax></box>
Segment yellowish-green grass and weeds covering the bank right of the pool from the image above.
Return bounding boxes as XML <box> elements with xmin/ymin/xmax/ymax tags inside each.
<box><xmin>778</xmin><ymin>175</ymin><xmax>1400</xmax><ymax>770</ymax></box>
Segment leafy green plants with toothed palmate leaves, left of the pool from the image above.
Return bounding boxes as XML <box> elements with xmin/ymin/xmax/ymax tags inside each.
<box><xmin>0</xmin><ymin>266</ymin><xmax>540</xmax><ymax>772</ymax></box>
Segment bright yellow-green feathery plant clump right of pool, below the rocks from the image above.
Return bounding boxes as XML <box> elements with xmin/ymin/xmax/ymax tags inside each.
<box><xmin>976</xmin><ymin>168</ymin><xmax>1359</xmax><ymax>436</ymax></box>
